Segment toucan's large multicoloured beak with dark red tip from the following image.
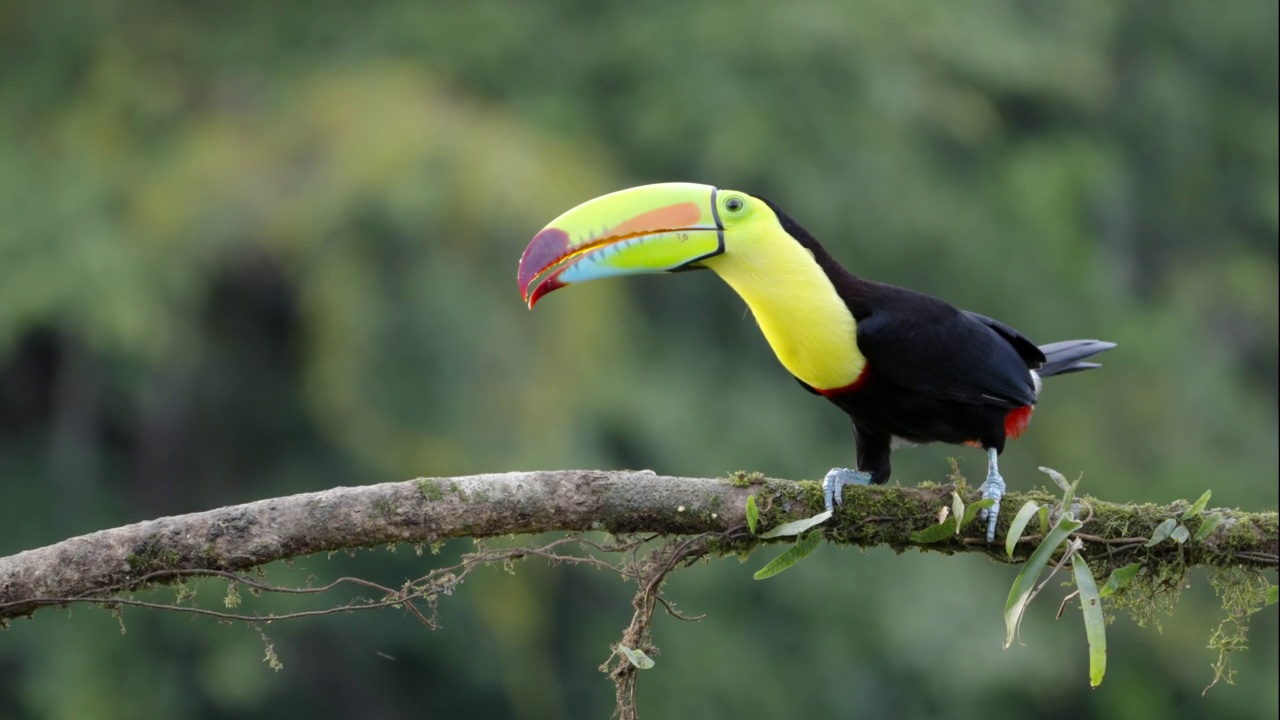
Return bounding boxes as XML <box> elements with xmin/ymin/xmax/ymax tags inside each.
<box><xmin>518</xmin><ymin>182</ymin><xmax>724</xmax><ymax>307</ymax></box>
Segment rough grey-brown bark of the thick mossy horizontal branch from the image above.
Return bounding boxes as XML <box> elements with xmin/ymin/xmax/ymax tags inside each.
<box><xmin>0</xmin><ymin>470</ymin><xmax>1277</xmax><ymax>620</ymax></box>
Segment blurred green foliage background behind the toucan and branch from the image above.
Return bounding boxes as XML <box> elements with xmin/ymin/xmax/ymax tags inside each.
<box><xmin>0</xmin><ymin>0</ymin><xmax>1280</xmax><ymax>720</ymax></box>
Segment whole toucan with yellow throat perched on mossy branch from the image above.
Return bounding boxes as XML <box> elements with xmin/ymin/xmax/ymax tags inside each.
<box><xmin>518</xmin><ymin>183</ymin><xmax>1115</xmax><ymax>542</ymax></box>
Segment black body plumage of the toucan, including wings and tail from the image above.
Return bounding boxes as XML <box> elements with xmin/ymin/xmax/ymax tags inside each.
<box><xmin>767</xmin><ymin>201</ymin><xmax>1115</xmax><ymax>484</ymax></box>
